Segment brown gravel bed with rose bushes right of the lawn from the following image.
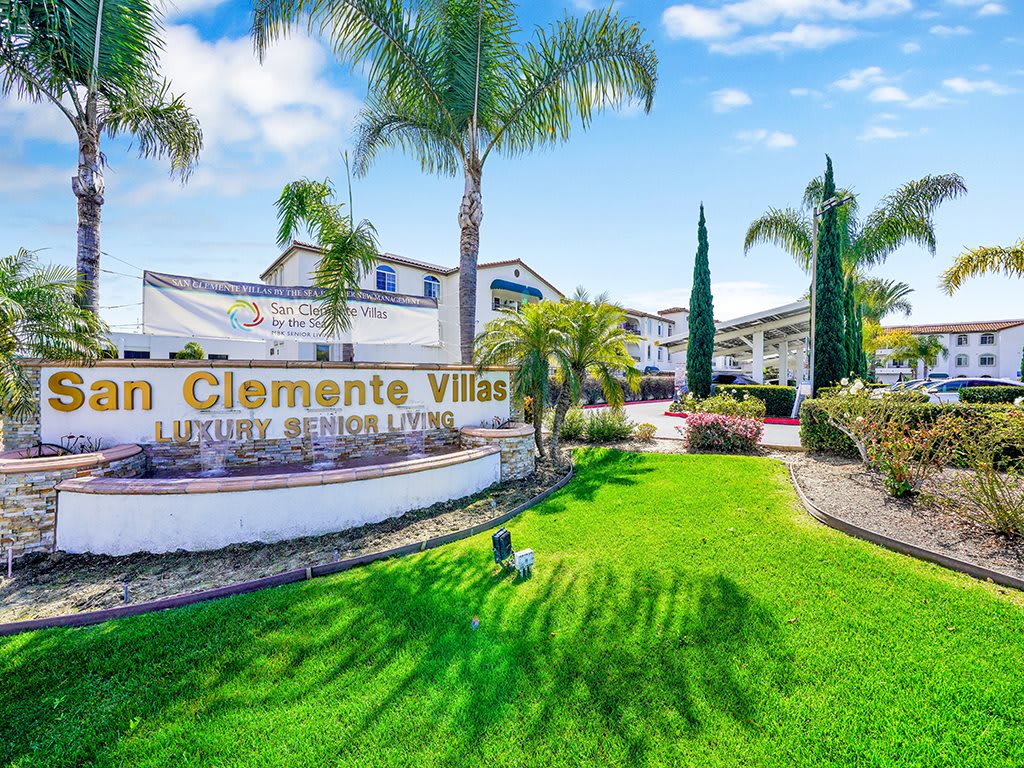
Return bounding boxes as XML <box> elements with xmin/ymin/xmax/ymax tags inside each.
<box><xmin>784</xmin><ymin>455</ymin><xmax>1024</xmax><ymax>579</ymax></box>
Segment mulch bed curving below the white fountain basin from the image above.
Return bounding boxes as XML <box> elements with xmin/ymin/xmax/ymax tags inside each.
<box><xmin>0</xmin><ymin>464</ymin><xmax>567</xmax><ymax>623</ymax></box>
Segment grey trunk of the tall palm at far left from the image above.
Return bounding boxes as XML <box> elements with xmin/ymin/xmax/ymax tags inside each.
<box><xmin>71</xmin><ymin>107</ymin><xmax>103</xmax><ymax>314</ymax></box>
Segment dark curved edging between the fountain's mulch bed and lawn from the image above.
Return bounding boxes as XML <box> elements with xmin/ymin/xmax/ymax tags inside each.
<box><xmin>0</xmin><ymin>462</ymin><xmax>575</xmax><ymax>637</ymax></box>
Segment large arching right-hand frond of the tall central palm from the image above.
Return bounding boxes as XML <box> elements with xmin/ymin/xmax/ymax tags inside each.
<box><xmin>482</xmin><ymin>8</ymin><xmax>657</xmax><ymax>159</ymax></box>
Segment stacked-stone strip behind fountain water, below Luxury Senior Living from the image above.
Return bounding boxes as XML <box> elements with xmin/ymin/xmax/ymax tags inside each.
<box><xmin>142</xmin><ymin>429</ymin><xmax>460</xmax><ymax>474</ymax></box>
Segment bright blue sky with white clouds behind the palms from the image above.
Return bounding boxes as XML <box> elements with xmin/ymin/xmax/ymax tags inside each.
<box><xmin>0</xmin><ymin>0</ymin><xmax>1024</xmax><ymax>330</ymax></box>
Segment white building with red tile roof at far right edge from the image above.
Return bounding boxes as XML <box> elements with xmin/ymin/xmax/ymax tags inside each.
<box><xmin>874</xmin><ymin>319</ymin><xmax>1024</xmax><ymax>383</ymax></box>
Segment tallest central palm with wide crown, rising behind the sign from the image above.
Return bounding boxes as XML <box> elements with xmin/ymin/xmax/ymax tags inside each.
<box><xmin>253</xmin><ymin>0</ymin><xmax>657</xmax><ymax>364</ymax></box>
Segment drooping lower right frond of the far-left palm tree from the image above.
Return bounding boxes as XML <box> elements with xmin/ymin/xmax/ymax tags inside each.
<box><xmin>99</xmin><ymin>81</ymin><xmax>203</xmax><ymax>182</ymax></box>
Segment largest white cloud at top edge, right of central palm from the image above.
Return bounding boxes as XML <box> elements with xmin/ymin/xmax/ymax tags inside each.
<box><xmin>662</xmin><ymin>0</ymin><xmax>913</xmax><ymax>54</ymax></box>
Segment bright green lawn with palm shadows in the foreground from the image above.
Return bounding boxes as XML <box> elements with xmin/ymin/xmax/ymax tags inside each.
<box><xmin>0</xmin><ymin>451</ymin><xmax>1024</xmax><ymax>768</ymax></box>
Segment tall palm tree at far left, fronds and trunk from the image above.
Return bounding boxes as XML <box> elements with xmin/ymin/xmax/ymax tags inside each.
<box><xmin>0</xmin><ymin>0</ymin><xmax>203</xmax><ymax>313</ymax></box>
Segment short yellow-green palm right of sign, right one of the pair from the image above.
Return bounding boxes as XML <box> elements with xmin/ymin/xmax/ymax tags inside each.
<box><xmin>551</xmin><ymin>288</ymin><xmax>640</xmax><ymax>464</ymax></box>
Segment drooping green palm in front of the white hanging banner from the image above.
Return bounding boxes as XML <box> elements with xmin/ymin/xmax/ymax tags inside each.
<box><xmin>275</xmin><ymin>178</ymin><xmax>380</xmax><ymax>337</ymax></box>
